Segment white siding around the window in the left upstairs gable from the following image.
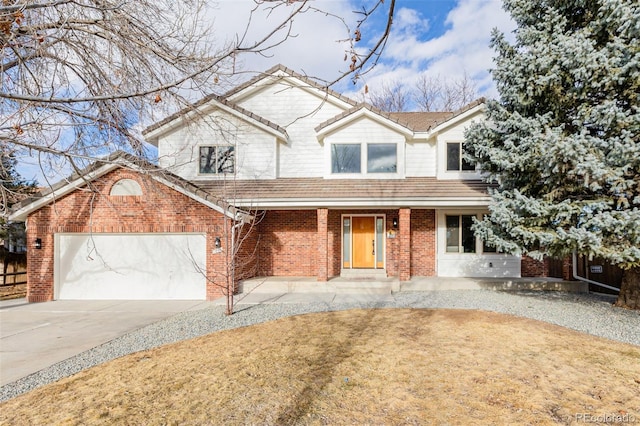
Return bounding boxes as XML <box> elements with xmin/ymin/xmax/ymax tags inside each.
<box><xmin>158</xmin><ymin>112</ymin><xmax>278</xmax><ymax>180</ymax></box>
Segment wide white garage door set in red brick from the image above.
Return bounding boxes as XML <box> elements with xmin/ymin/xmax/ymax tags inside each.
<box><xmin>55</xmin><ymin>234</ymin><xmax>206</xmax><ymax>300</ymax></box>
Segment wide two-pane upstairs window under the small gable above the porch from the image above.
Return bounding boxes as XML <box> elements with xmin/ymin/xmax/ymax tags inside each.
<box><xmin>331</xmin><ymin>143</ymin><xmax>398</xmax><ymax>173</ymax></box>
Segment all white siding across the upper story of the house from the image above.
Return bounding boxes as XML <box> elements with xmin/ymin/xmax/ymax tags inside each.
<box><xmin>151</xmin><ymin>71</ymin><xmax>490</xmax><ymax>180</ymax></box>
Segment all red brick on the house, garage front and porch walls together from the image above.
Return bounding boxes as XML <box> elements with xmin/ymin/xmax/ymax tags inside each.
<box><xmin>27</xmin><ymin>169</ymin><xmax>552</xmax><ymax>302</ymax></box>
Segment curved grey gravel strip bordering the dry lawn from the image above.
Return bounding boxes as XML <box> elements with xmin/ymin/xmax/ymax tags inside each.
<box><xmin>0</xmin><ymin>290</ymin><xmax>640</xmax><ymax>402</ymax></box>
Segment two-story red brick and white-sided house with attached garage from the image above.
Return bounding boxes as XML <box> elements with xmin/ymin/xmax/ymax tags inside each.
<box><xmin>12</xmin><ymin>66</ymin><xmax>535</xmax><ymax>301</ymax></box>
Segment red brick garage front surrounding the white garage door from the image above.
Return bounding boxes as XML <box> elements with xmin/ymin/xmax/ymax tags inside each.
<box><xmin>27</xmin><ymin>169</ymin><xmax>226</xmax><ymax>302</ymax></box>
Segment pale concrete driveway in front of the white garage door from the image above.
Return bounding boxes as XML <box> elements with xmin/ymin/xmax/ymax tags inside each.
<box><xmin>0</xmin><ymin>299</ymin><xmax>211</xmax><ymax>386</ymax></box>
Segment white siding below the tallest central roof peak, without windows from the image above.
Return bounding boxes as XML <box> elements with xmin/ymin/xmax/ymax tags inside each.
<box><xmin>238</xmin><ymin>84</ymin><xmax>346</xmax><ymax>177</ymax></box>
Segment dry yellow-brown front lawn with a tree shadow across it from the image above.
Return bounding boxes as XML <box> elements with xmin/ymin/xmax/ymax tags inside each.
<box><xmin>0</xmin><ymin>309</ymin><xmax>640</xmax><ymax>425</ymax></box>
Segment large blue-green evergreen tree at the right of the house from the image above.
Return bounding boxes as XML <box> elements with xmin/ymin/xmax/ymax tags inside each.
<box><xmin>465</xmin><ymin>0</ymin><xmax>640</xmax><ymax>309</ymax></box>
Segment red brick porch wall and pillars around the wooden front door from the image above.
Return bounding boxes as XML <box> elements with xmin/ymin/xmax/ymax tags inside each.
<box><xmin>255</xmin><ymin>209</ymin><xmax>436</xmax><ymax>281</ymax></box>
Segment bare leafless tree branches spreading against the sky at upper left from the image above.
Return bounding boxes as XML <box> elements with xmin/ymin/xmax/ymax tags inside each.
<box><xmin>0</xmin><ymin>0</ymin><xmax>395</xmax><ymax>213</ymax></box>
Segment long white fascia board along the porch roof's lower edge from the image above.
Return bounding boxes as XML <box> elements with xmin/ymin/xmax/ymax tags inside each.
<box><xmin>229</xmin><ymin>197</ymin><xmax>491</xmax><ymax>209</ymax></box>
